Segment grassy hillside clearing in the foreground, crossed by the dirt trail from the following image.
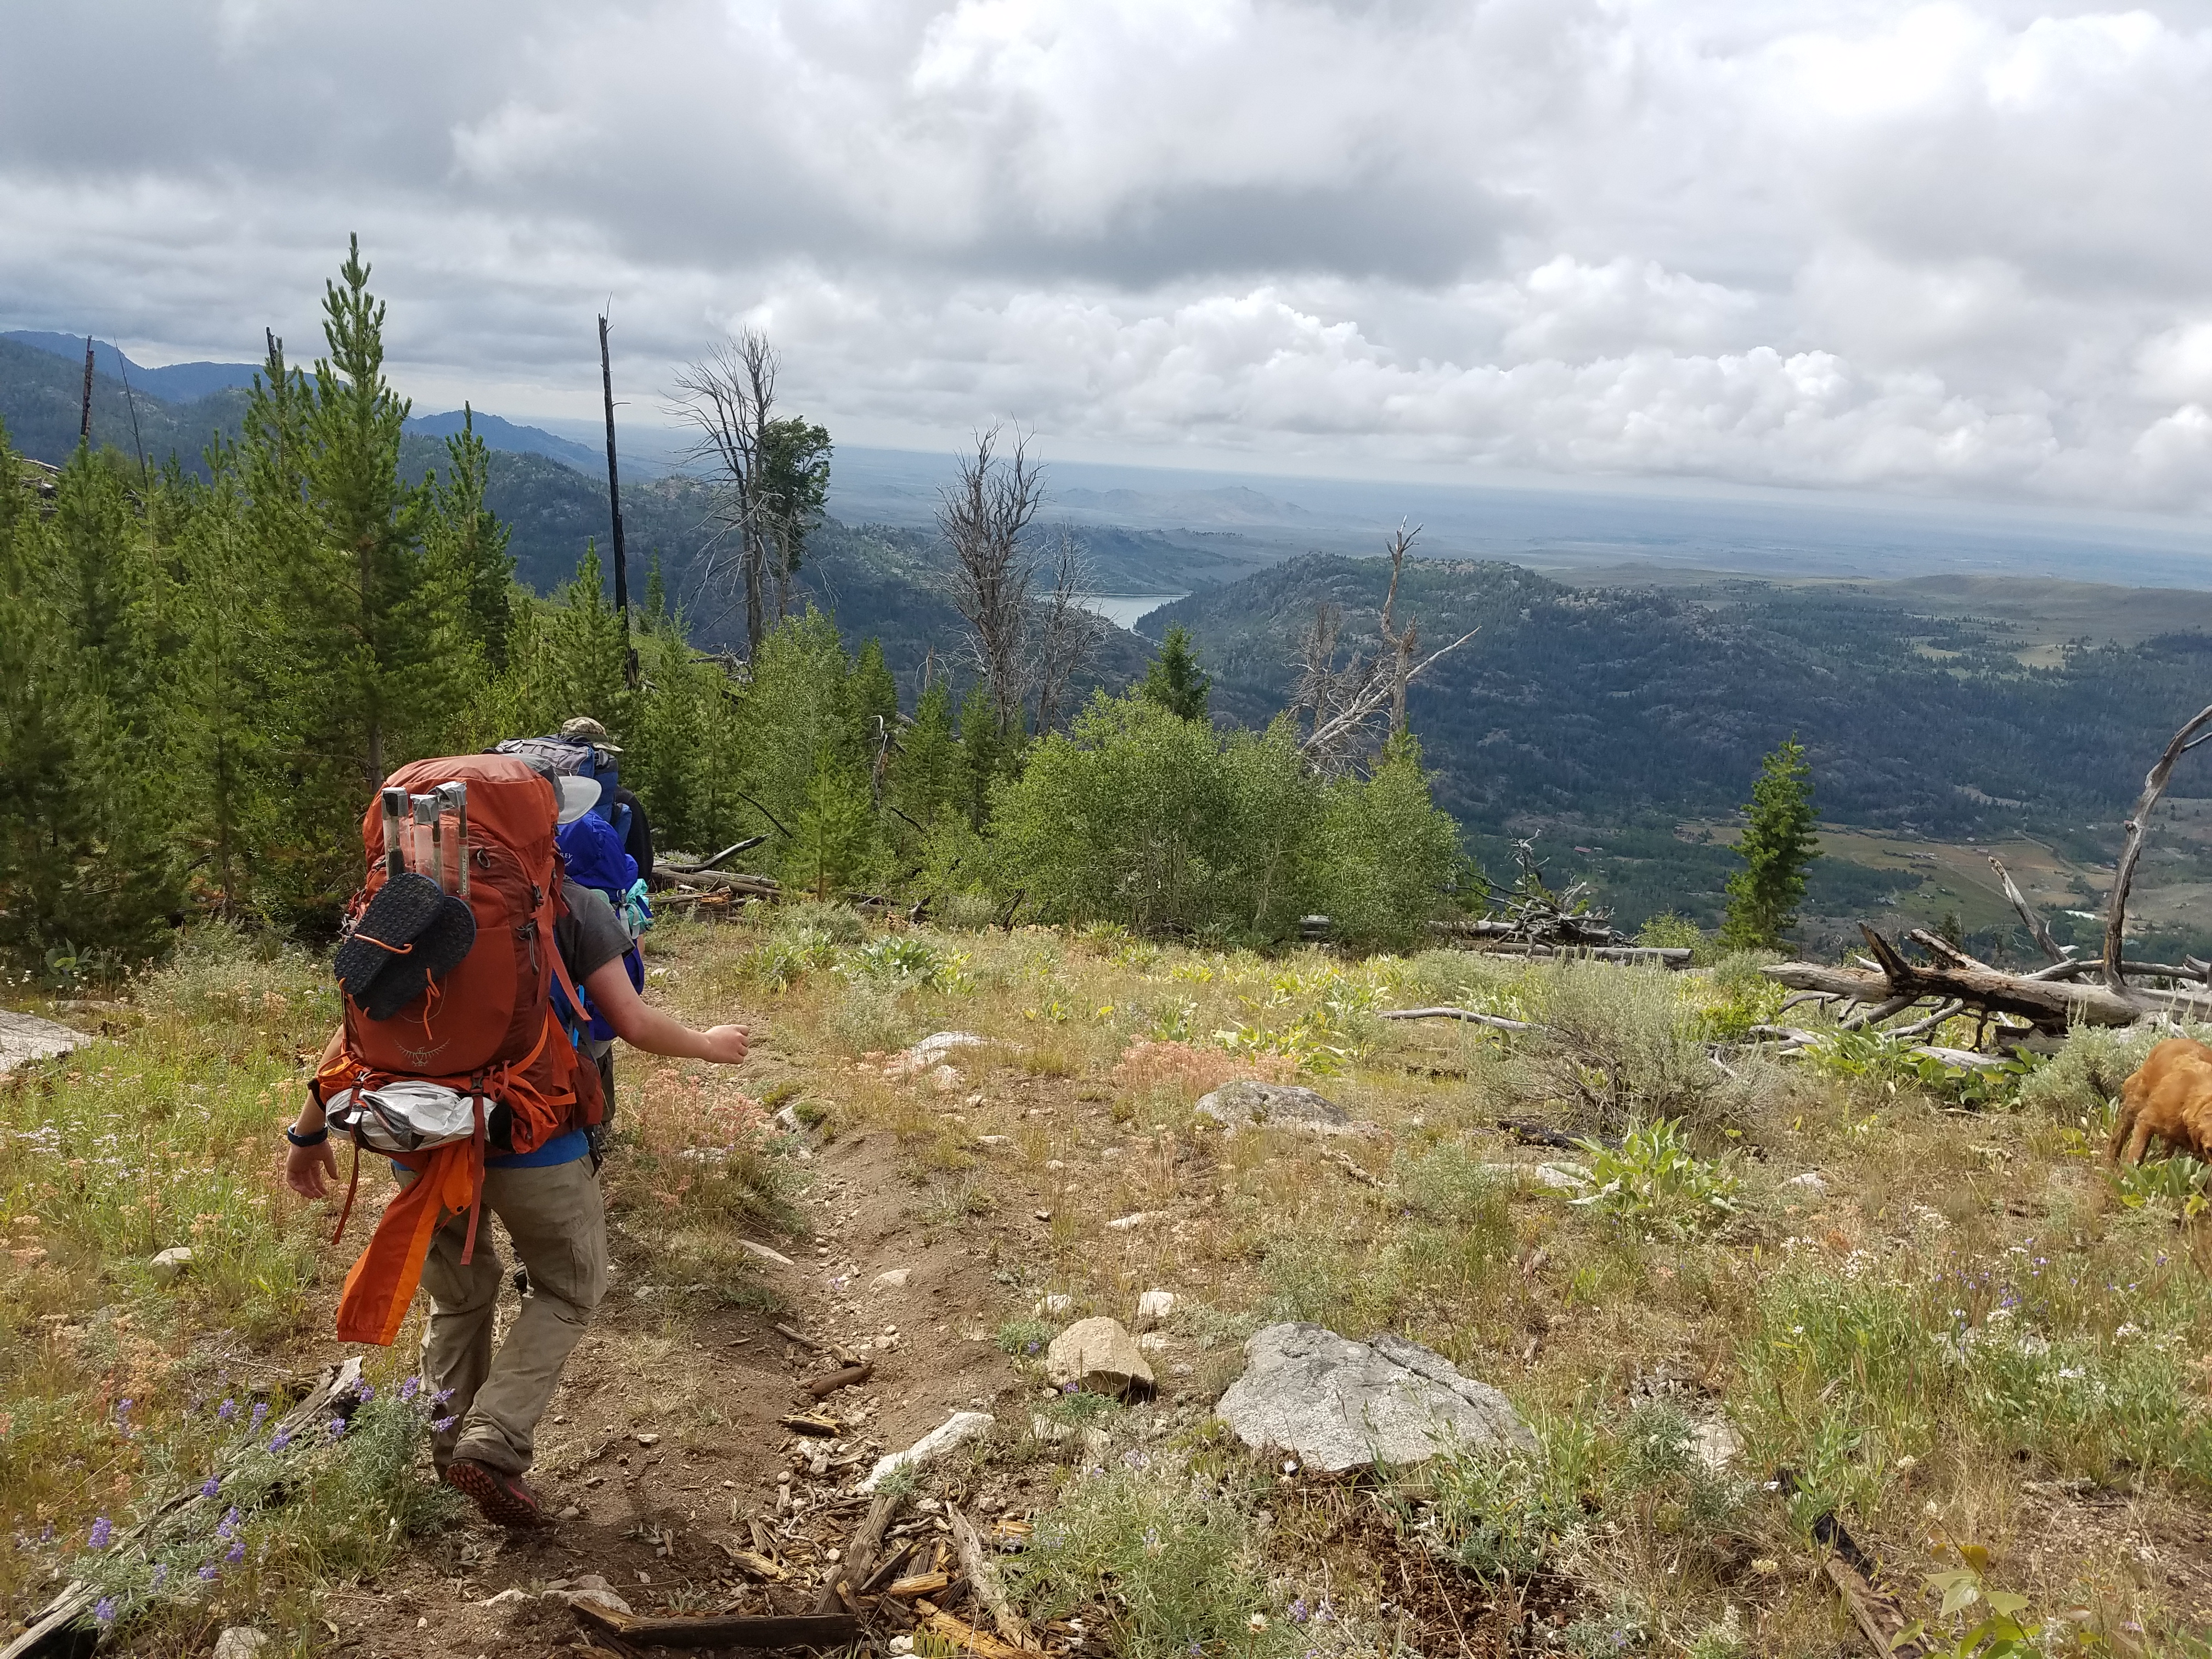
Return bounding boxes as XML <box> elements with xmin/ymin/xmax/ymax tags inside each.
<box><xmin>0</xmin><ymin>907</ymin><xmax>2212</xmax><ymax>1659</ymax></box>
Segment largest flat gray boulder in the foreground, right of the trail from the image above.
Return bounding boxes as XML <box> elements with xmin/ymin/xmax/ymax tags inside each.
<box><xmin>1215</xmin><ymin>1323</ymin><xmax>1535</xmax><ymax>1473</ymax></box>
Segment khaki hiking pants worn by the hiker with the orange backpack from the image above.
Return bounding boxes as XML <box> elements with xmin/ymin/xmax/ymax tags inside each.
<box><xmin>404</xmin><ymin>1157</ymin><xmax>606</xmax><ymax>1475</ymax></box>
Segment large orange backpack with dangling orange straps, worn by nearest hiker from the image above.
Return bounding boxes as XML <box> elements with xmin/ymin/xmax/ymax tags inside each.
<box><xmin>309</xmin><ymin>754</ymin><xmax>604</xmax><ymax>1345</ymax></box>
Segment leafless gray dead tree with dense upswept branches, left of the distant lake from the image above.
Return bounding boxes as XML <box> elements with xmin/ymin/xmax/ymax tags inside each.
<box><xmin>938</xmin><ymin>427</ymin><xmax>1044</xmax><ymax>725</ymax></box>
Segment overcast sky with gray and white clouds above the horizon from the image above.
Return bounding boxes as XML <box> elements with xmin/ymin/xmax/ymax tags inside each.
<box><xmin>0</xmin><ymin>0</ymin><xmax>2212</xmax><ymax>513</ymax></box>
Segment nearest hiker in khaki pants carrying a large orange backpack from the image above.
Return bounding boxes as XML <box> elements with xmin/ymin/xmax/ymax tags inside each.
<box><xmin>285</xmin><ymin>754</ymin><xmax>746</xmax><ymax>1526</ymax></box>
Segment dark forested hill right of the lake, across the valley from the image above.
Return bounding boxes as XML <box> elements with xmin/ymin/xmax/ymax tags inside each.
<box><xmin>1144</xmin><ymin>555</ymin><xmax>2212</xmax><ymax>836</ymax></box>
